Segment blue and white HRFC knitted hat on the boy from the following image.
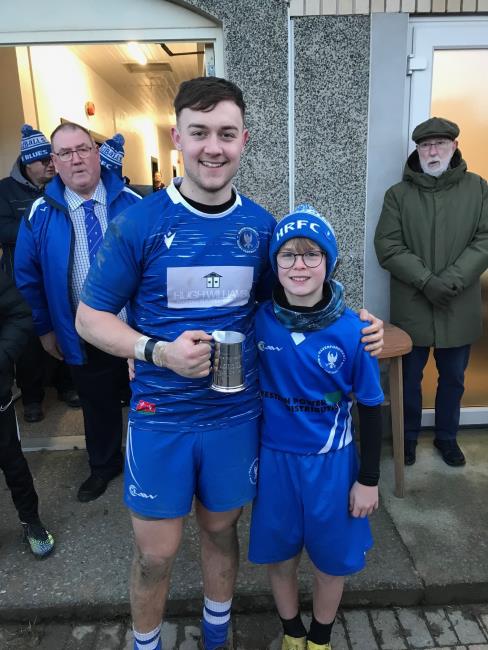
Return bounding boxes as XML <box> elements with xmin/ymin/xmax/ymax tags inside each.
<box><xmin>269</xmin><ymin>203</ymin><xmax>339</xmax><ymax>280</ymax></box>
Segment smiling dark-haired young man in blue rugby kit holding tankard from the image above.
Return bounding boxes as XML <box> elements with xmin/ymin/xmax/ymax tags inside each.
<box><xmin>77</xmin><ymin>77</ymin><xmax>382</xmax><ymax>650</ymax></box>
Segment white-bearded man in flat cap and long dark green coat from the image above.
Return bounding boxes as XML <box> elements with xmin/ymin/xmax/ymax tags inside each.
<box><xmin>375</xmin><ymin>117</ymin><xmax>488</xmax><ymax>467</ymax></box>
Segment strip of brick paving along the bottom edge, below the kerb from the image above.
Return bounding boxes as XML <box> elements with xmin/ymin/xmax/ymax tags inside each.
<box><xmin>4</xmin><ymin>604</ymin><xmax>488</xmax><ymax>650</ymax></box>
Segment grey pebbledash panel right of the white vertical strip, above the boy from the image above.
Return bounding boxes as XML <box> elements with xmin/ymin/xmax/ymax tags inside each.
<box><xmin>294</xmin><ymin>16</ymin><xmax>370</xmax><ymax>308</ymax></box>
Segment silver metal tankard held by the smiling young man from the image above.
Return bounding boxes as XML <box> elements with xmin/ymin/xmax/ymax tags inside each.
<box><xmin>211</xmin><ymin>331</ymin><xmax>246</xmax><ymax>393</ymax></box>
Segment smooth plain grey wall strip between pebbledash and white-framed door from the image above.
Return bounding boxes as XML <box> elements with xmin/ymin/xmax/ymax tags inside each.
<box><xmin>364</xmin><ymin>14</ymin><xmax>408</xmax><ymax>320</ymax></box>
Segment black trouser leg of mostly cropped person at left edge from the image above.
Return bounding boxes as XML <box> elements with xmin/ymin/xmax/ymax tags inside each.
<box><xmin>0</xmin><ymin>402</ymin><xmax>39</xmax><ymax>523</ymax></box>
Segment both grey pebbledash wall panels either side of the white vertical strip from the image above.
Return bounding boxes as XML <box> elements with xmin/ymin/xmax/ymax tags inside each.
<box><xmin>185</xmin><ymin>0</ymin><xmax>370</xmax><ymax>306</ymax></box>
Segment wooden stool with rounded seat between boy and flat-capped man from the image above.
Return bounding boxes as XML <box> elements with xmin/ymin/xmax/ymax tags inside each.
<box><xmin>378</xmin><ymin>323</ymin><xmax>412</xmax><ymax>497</ymax></box>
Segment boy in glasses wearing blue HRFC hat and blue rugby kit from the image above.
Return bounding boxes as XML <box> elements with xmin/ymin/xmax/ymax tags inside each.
<box><xmin>249</xmin><ymin>205</ymin><xmax>383</xmax><ymax>650</ymax></box>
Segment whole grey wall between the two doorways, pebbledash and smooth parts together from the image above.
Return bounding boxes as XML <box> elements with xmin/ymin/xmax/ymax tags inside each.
<box><xmin>184</xmin><ymin>0</ymin><xmax>488</xmax><ymax>318</ymax></box>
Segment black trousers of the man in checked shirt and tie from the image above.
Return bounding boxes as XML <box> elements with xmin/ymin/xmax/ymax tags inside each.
<box><xmin>70</xmin><ymin>344</ymin><xmax>129</xmax><ymax>480</ymax></box>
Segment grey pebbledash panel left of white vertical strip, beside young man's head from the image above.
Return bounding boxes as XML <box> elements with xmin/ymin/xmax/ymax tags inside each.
<box><xmin>177</xmin><ymin>0</ymin><xmax>288</xmax><ymax>216</ymax></box>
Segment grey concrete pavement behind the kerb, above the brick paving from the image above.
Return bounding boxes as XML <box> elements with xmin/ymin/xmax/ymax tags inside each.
<box><xmin>0</xmin><ymin>409</ymin><xmax>488</xmax><ymax>620</ymax></box>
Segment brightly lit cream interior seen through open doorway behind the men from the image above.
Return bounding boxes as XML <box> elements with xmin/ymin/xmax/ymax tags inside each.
<box><xmin>0</xmin><ymin>41</ymin><xmax>211</xmax><ymax>193</ymax></box>
